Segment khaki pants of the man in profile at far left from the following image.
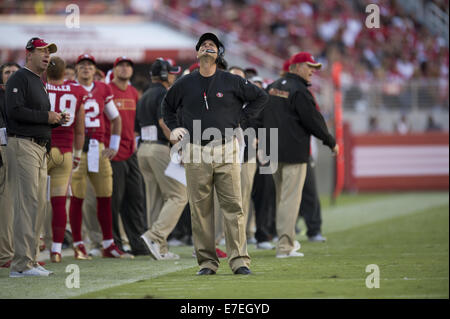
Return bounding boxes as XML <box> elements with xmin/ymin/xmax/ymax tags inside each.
<box><xmin>6</xmin><ymin>137</ymin><xmax>47</xmax><ymax>271</ymax></box>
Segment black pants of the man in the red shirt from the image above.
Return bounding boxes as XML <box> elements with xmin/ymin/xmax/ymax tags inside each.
<box><xmin>111</xmin><ymin>153</ymin><xmax>149</xmax><ymax>255</ymax></box>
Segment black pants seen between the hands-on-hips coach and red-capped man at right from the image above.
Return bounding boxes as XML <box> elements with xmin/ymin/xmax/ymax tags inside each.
<box><xmin>252</xmin><ymin>166</ymin><xmax>276</xmax><ymax>243</ymax></box>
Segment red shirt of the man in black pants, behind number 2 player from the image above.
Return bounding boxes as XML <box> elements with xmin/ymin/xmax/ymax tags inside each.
<box><xmin>105</xmin><ymin>82</ymin><xmax>139</xmax><ymax>161</ymax></box>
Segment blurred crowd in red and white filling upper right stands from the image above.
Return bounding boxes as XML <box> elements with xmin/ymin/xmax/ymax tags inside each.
<box><xmin>165</xmin><ymin>0</ymin><xmax>449</xmax><ymax>81</ymax></box>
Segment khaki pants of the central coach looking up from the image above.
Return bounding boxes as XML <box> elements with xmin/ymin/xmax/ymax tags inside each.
<box><xmin>183</xmin><ymin>139</ymin><xmax>250</xmax><ymax>271</ymax></box>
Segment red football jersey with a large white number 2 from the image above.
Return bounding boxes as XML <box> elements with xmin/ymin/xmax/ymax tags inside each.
<box><xmin>84</xmin><ymin>81</ymin><xmax>113</xmax><ymax>143</ymax></box>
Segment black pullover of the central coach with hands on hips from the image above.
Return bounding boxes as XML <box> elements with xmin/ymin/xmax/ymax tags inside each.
<box><xmin>162</xmin><ymin>70</ymin><xmax>268</xmax><ymax>143</ymax></box>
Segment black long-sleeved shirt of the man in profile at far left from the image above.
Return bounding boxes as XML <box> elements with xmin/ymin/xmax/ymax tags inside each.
<box><xmin>6</xmin><ymin>68</ymin><xmax>55</xmax><ymax>141</ymax></box>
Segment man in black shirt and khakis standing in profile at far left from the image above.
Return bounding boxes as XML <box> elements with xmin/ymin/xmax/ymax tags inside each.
<box><xmin>6</xmin><ymin>38</ymin><xmax>69</xmax><ymax>277</ymax></box>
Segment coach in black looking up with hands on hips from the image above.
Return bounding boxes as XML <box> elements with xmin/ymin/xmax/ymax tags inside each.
<box><xmin>163</xmin><ymin>33</ymin><xmax>267</xmax><ymax>275</ymax></box>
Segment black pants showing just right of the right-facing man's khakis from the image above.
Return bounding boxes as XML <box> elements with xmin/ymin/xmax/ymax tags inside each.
<box><xmin>299</xmin><ymin>158</ymin><xmax>322</xmax><ymax>237</ymax></box>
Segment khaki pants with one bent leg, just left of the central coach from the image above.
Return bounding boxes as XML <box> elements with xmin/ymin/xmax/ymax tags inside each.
<box><xmin>137</xmin><ymin>143</ymin><xmax>187</xmax><ymax>254</ymax></box>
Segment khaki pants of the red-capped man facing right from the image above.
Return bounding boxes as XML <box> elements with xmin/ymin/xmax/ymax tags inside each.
<box><xmin>273</xmin><ymin>163</ymin><xmax>307</xmax><ymax>254</ymax></box>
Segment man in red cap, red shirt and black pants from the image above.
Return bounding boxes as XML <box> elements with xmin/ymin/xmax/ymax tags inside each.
<box><xmin>105</xmin><ymin>56</ymin><xmax>148</xmax><ymax>255</ymax></box>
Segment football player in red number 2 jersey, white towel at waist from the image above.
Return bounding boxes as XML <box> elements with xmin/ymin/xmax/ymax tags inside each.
<box><xmin>69</xmin><ymin>54</ymin><xmax>129</xmax><ymax>259</ymax></box>
